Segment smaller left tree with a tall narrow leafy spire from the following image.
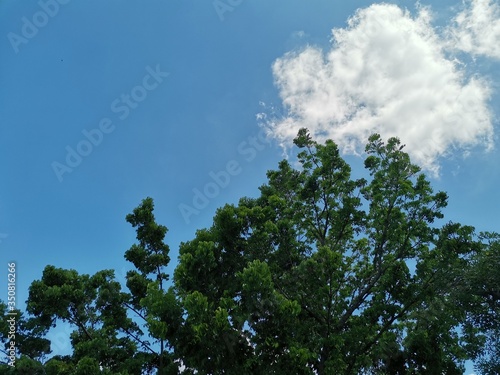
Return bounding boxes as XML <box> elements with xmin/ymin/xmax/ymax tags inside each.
<box><xmin>20</xmin><ymin>198</ymin><xmax>180</xmax><ymax>375</ymax></box>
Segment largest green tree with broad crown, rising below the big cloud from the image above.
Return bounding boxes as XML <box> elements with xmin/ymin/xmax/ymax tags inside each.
<box><xmin>166</xmin><ymin>129</ymin><xmax>486</xmax><ymax>374</ymax></box>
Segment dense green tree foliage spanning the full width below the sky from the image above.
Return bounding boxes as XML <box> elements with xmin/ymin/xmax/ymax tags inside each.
<box><xmin>0</xmin><ymin>129</ymin><xmax>500</xmax><ymax>375</ymax></box>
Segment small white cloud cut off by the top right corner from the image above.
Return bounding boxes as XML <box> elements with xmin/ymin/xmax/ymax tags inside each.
<box><xmin>448</xmin><ymin>0</ymin><xmax>500</xmax><ymax>59</ymax></box>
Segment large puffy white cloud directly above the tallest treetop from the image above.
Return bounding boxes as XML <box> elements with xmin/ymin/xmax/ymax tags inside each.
<box><xmin>267</xmin><ymin>4</ymin><xmax>493</xmax><ymax>174</ymax></box>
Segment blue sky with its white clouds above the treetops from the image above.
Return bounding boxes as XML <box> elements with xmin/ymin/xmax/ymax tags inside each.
<box><xmin>0</xmin><ymin>0</ymin><xmax>500</xmax><ymax>372</ymax></box>
